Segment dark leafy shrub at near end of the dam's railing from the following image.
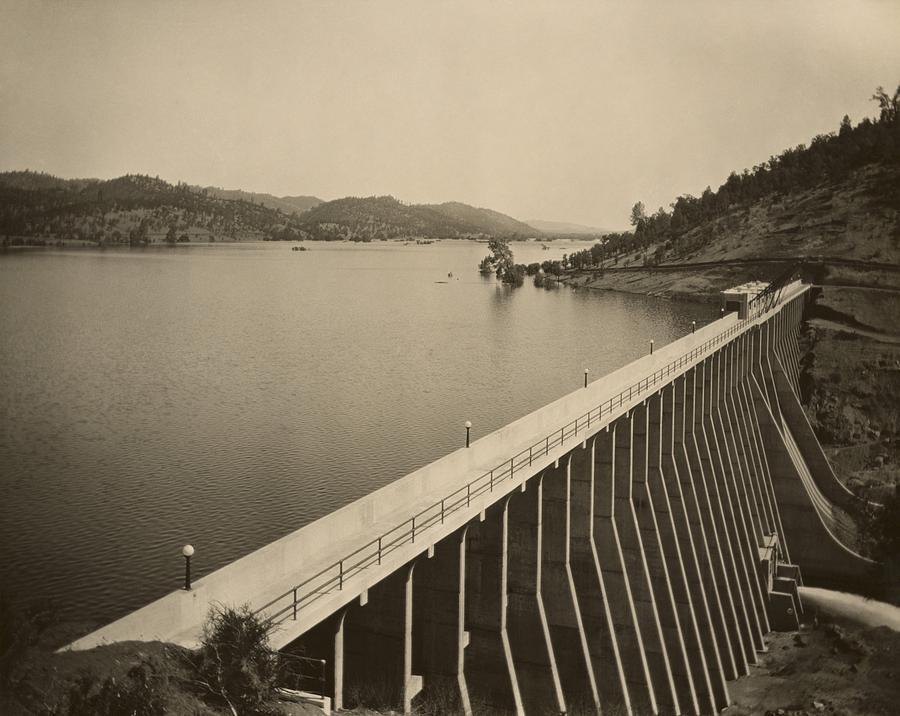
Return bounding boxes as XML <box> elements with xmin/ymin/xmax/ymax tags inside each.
<box><xmin>195</xmin><ymin>605</ymin><xmax>278</xmax><ymax>716</ymax></box>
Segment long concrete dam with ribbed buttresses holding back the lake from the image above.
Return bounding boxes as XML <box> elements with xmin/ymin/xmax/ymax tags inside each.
<box><xmin>67</xmin><ymin>282</ymin><xmax>872</xmax><ymax>714</ymax></box>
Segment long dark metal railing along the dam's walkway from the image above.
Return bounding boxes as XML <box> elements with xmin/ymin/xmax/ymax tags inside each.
<box><xmin>255</xmin><ymin>286</ymin><xmax>800</xmax><ymax>624</ymax></box>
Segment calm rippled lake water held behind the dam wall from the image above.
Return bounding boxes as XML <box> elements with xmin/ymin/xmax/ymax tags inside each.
<box><xmin>0</xmin><ymin>241</ymin><xmax>715</xmax><ymax>621</ymax></box>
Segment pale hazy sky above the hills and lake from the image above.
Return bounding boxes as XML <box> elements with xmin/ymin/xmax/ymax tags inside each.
<box><xmin>0</xmin><ymin>0</ymin><xmax>900</xmax><ymax>228</ymax></box>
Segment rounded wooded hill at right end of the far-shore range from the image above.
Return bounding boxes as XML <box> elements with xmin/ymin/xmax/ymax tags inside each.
<box><xmin>298</xmin><ymin>196</ymin><xmax>540</xmax><ymax>241</ymax></box>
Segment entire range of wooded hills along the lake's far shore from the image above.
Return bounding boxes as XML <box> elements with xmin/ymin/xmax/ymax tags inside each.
<box><xmin>0</xmin><ymin>171</ymin><xmax>539</xmax><ymax>245</ymax></box>
